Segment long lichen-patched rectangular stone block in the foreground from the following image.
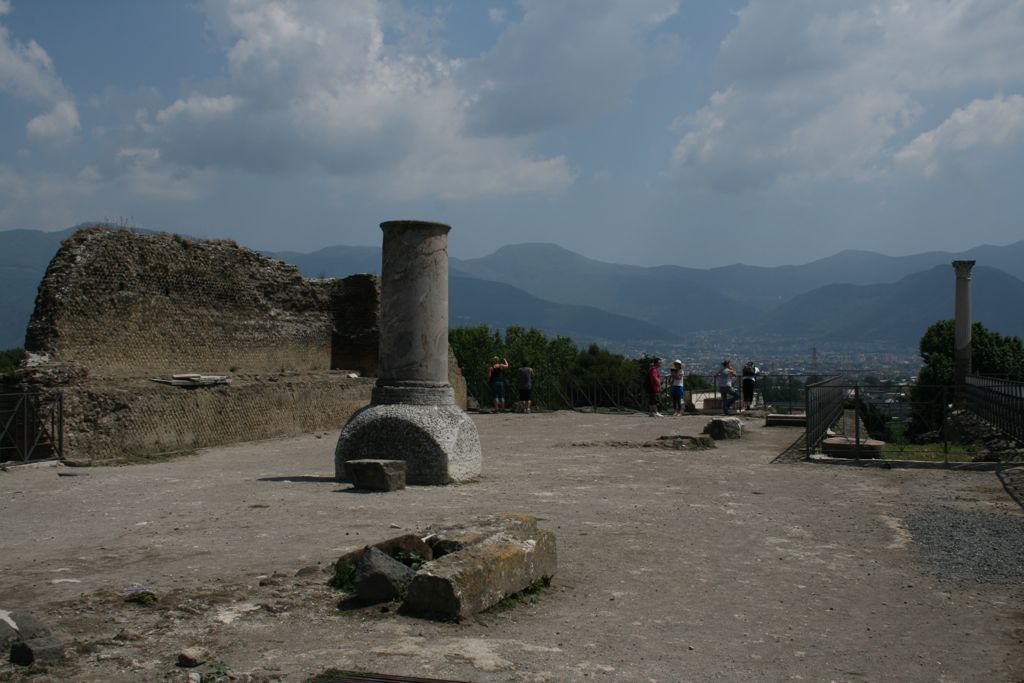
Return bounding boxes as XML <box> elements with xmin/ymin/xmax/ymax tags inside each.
<box><xmin>402</xmin><ymin>515</ymin><xmax>558</xmax><ymax>621</ymax></box>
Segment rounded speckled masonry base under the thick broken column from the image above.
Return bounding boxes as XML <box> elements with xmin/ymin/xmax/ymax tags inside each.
<box><xmin>334</xmin><ymin>405</ymin><xmax>482</xmax><ymax>485</ymax></box>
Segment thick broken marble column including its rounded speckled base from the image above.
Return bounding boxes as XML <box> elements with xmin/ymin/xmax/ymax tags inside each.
<box><xmin>334</xmin><ymin>220</ymin><xmax>481</xmax><ymax>484</ymax></box>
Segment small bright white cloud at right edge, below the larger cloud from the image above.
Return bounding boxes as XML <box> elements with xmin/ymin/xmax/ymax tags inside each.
<box><xmin>896</xmin><ymin>95</ymin><xmax>1024</xmax><ymax>176</ymax></box>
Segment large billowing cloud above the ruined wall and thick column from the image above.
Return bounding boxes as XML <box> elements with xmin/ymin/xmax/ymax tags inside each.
<box><xmin>126</xmin><ymin>0</ymin><xmax>574</xmax><ymax>198</ymax></box>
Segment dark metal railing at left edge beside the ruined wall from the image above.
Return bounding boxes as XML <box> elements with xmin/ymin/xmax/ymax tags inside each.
<box><xmin>0</xmin><ymin>393</ymin><xmax>63</xmax><ymax>463</ymax></box>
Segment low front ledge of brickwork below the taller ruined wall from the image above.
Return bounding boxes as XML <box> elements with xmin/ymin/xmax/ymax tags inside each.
<box><xmin>57</xmin><ymin>372</ymin><xmax>374</xmax><ymax>463</ymax></box>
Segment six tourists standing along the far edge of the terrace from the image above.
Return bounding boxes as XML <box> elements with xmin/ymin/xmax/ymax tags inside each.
<box><xmin>487</xmin><ymin>355</ymin><xmax>761</xmax><ymax>418</ymax></box>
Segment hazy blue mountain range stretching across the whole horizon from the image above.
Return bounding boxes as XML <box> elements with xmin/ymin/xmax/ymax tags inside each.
<box><xmin>0</xmin><ymin>228</ymin><xmax>1024</xmax><ymax>348</ymax></box>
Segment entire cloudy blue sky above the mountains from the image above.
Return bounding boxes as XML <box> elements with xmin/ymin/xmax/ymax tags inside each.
<box><xmin>0</xmin><ymin>0</ymin><xmax>1024</xmax><ymax>267</ymax></box>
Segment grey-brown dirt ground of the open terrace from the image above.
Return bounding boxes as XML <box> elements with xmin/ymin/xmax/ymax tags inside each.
<box><xmin>0</xmin><ymin>413</ymin><xmax>1024</xmax><ymax>683</ymax></box>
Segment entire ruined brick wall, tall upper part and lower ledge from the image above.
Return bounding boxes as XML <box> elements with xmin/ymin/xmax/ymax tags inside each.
<box><xmin>19</xmin><ymin>227</ymin><xmax>465</xmax><ymax>461</ymax></box>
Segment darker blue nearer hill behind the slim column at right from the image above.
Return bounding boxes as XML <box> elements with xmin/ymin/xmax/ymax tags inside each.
<box><xmin>751</xmin><ymin>265</ymin><xmax>1024</xmax><ymax>344</ymax></box>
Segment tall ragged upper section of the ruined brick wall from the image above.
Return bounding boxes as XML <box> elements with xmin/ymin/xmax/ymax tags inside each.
<box><xmin>26</xmin><ymin>226</ymin><xmax>337</xmax><ymax>377</ymax></box>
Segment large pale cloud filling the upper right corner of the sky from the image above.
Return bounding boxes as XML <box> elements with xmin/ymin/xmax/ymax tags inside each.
<box><xmin>673</xmin><ymin>0</ymin><xmax>1024</xmax><ymax>191</ymax></box>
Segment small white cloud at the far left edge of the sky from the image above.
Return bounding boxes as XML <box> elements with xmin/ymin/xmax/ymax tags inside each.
<box><xmin>0</xmin><ymin>10</ymin><xmax>80</xmax><ymax>144</ymax></box>
